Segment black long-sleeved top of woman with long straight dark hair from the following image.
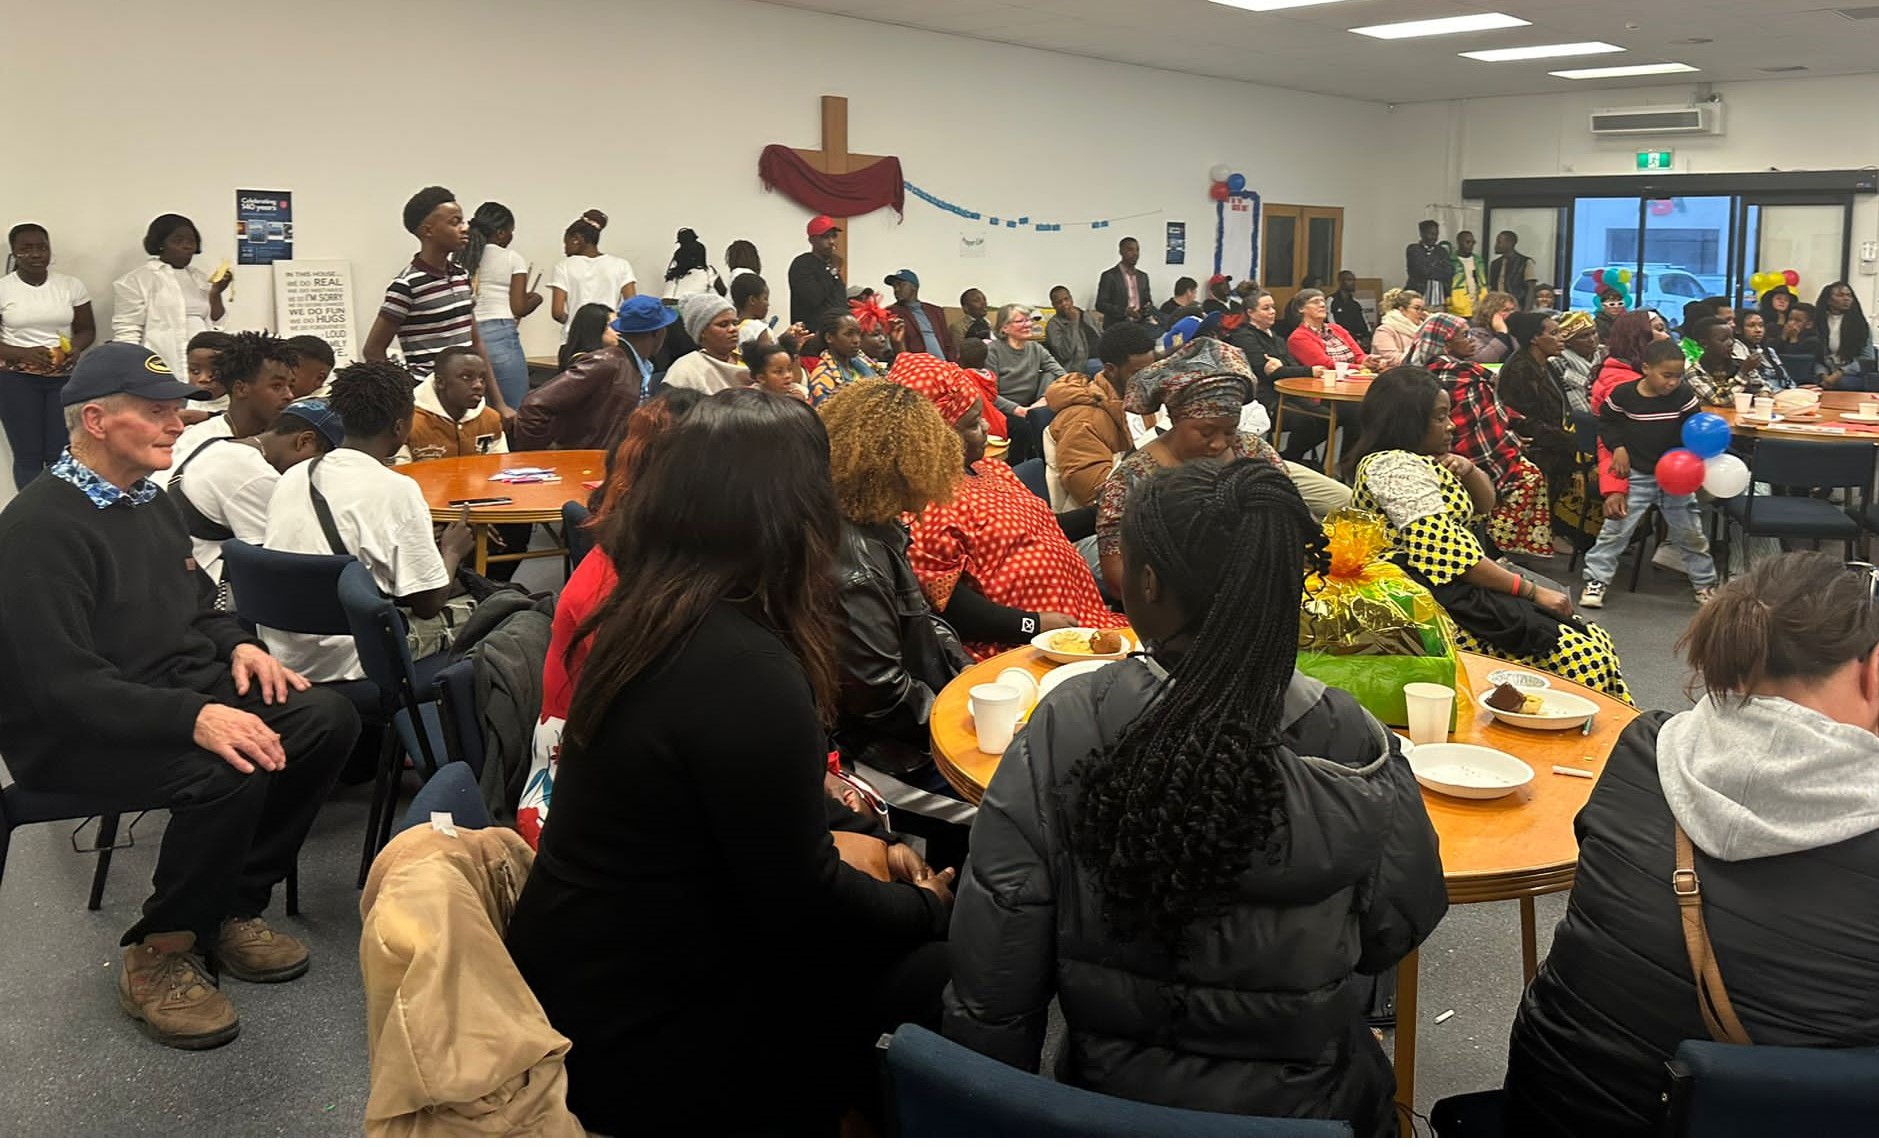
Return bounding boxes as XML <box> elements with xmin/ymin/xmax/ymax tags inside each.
<box><xmin>509</xmin><ymin>604</ymin><xmax>949</xmax><ymax>1134</ymax></box>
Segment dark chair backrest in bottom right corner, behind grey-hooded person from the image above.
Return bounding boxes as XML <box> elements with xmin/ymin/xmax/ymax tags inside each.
<box><xmin>1665</xmin><ymin>1040</ymin><xmax>1879</xmax><ymax>1139</ymax></box>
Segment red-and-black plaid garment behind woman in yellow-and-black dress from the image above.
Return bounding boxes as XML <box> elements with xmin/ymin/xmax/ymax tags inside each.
<box><xmin>1428</xmin><ymin>355</ymin><xmax>1552</xmax><ymax>558</ymax></box>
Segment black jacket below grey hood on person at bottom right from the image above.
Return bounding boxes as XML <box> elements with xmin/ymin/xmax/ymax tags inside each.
<box><xmin>1507</xmin><ymin>713</ymin><xmax>1879</xmax><ymax>1136</ymax></box>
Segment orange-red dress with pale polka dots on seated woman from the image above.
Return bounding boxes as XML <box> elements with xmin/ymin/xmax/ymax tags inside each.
<box><xmin>908</xmin><ymin>459</ymin><xmax>1129</xmax><ymax>660</ymax></box>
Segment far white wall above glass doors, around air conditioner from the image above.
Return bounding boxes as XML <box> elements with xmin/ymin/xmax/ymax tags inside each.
<box><xmin>1375</xmin><ymin>75</ymin><xmax>1879</xmax><ymax>298</ymax></box>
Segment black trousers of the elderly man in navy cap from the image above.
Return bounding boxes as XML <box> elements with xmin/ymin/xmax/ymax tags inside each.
<box><xmin>21</xmin><ymin>675</ymin><xmax>359</xmax><ymax>948</ymax></box>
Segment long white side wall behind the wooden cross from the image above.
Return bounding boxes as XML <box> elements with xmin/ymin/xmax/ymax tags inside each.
<box><xmin>0</xmin><ymin>0</ymin><xmax>1413</xmax><ymax>368</ymax></box>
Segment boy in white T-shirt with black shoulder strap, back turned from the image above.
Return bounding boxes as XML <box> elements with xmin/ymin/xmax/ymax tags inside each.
<box><xmin>261</xmin><ymin>363</ymin><xmax>474</xmax><ymax>681</ymax></box>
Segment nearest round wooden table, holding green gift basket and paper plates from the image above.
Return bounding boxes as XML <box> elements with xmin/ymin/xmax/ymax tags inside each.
<box><xmin>928</xmin><ymin>647</ymin><xmax>1638</xmax><ymax>1104</ymax></box>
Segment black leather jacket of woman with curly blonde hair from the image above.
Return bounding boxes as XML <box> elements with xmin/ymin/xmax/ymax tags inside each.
<box><xmin>834</xmin><ymin>523</ymin><xmax>971</xmax><ymax>777</ymax></box>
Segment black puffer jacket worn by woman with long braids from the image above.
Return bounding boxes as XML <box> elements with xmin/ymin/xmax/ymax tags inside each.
<box><xmin>945</xmin><ymin>658</ymin><xmax>1449</xmax><ymax>1134</ymax></box>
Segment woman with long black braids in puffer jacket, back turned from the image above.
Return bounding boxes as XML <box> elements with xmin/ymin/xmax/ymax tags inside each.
<box><xmin>943</xmin><ymin>459</ymin><xmax>1447</xmax><ymax>1134</ymax></box>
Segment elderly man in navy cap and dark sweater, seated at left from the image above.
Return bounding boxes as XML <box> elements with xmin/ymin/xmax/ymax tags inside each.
<box><xmin>0</xmin><ymin>342</ymin><xmax>359</xmax><ymax>1047</ymax></box>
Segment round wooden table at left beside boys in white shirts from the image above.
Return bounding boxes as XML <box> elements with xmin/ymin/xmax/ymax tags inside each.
<box><xmin>398</xmin><ymin>449</ymin><xmax>607</xmax><ymax>574</ymax></box>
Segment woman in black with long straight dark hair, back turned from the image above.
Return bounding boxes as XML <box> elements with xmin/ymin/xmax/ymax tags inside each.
<box><xmin>509</xmin><ymin>387</ymin><xmax>953</xmax><ymax>1136</ymax></box>
